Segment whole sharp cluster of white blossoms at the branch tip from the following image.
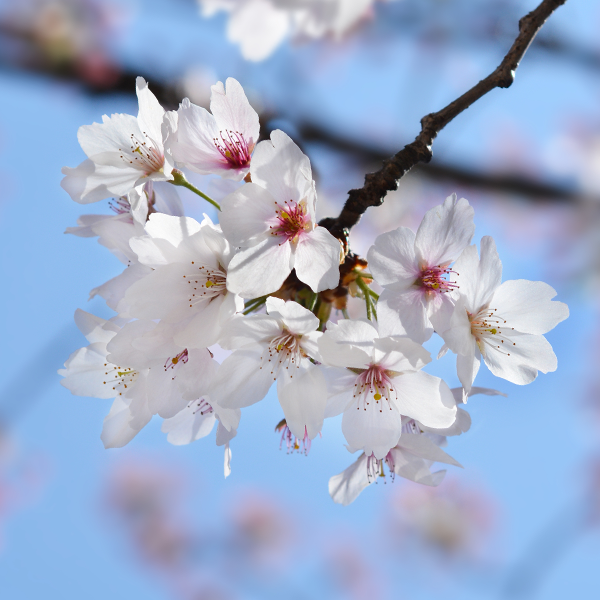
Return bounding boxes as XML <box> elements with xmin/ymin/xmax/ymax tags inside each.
<box><xmin>60</xmin><ymin>78</ymin><xmax>568</xmax><ymax>504</ymax></box>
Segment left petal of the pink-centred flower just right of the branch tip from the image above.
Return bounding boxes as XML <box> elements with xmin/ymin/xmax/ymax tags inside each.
<box><xmin>367</xmin><ymin>227</ymin><xmax>419</xmax><ymax>291</ymax></box>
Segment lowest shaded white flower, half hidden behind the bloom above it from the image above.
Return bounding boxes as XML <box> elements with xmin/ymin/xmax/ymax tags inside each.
<box><xmin>329</xmin><ymin>388</ymin><xmax>504</xmax><ymax>506</ymax></box>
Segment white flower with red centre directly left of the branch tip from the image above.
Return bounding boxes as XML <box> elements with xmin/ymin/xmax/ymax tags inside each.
<box><xmin>219</xmin><ymin>130</ymin><xmax>341</xmax><ymax>298</ymax></box>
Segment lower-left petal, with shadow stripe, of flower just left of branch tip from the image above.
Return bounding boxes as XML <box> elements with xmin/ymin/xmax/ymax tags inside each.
<box><xmin>227</xmin><ymin>237</ymin><xmax>292</xmax><ymax>298</ymax></box>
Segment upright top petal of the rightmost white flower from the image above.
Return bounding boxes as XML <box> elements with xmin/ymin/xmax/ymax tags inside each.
<box><xmin>452</xmin><ymin>236</ymin><xmax>502</xmax><ymax>314</ymax></box>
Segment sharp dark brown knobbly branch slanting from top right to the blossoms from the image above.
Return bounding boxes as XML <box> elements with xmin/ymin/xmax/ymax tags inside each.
<box><xmin>322</xmin><ymin>0</ymin><xmax>566</xmax><ymax>239</ymax></box>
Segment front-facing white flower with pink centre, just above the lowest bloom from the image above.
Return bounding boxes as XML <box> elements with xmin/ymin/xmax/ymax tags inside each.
<box><xmin>319</xmin><ymin>320</ymin><xmax>456</xmax><ymax>459</ymax></box>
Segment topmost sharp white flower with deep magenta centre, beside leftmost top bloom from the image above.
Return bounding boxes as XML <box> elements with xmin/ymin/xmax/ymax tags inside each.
<box><xmin>167</xmin><ymin>77</ymin><xmax>260</xmax><ymax>181</ymax></box>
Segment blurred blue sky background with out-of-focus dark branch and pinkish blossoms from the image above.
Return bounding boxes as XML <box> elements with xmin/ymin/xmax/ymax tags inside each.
<box><xmin>0</xmin><ymin>0</ymin><xmax>600</xmax><ymax>600</ymax></box>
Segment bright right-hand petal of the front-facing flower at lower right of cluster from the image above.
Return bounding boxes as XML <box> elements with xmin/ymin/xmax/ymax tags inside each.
<box><xmin>391</xmin><ymin>371</ymin><xmax>456</xmax><ymax>428</ymax></box>
